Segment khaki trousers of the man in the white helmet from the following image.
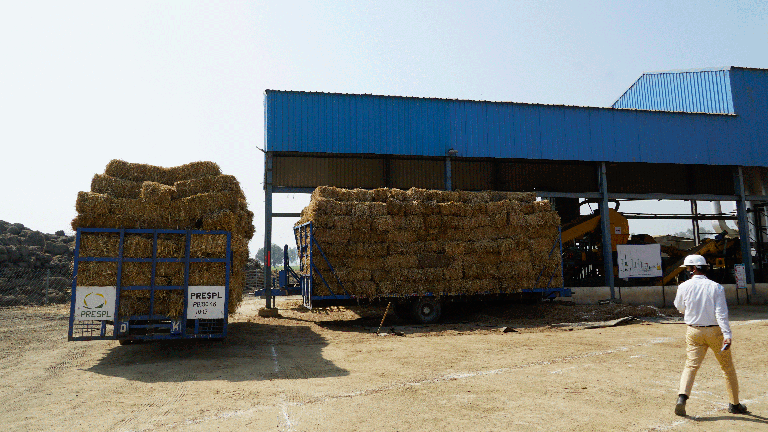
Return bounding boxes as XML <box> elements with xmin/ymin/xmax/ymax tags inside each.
<box><xmin>678</xmin><ymin>326</ymin><xmax>739</xmax><ymax>405</ymax></box>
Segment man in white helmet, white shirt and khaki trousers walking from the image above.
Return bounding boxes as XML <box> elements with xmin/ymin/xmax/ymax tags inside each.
<box><xmin>675</xmin><ymin>255</ymin><xmax>748</xmax><ymax>416</ymax></box>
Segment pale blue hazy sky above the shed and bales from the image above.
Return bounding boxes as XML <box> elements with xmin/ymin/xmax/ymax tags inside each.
<box><xmin>0</xmin><ymin>0</ymin><xmax>768</xmax><ymax>248</ymax></box>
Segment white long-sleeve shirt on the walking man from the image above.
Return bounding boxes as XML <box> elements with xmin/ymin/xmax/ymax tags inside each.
<box><xmin>675</xmin><ymin>275</ymin><xmax>731</xmax><ymax>339</ymax></box>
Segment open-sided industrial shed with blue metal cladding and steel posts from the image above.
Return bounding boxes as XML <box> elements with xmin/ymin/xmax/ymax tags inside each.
<box><xmin>264</xmin><ymin>67</ymin><xmax>768</xmax><ymax>307</ymax></box>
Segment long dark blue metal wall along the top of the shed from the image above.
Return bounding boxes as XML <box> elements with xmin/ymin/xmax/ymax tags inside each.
<box><xmin>265</xmin><ymin>68</ymin><xmax>768</xmax><ymax>166</ymax></box>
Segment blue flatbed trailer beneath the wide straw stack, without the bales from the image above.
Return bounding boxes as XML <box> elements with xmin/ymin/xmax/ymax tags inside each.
<box><xmin>292</xmin><ymin>222</ymin><xmax>572</xmax><ymax>323</ymax></box>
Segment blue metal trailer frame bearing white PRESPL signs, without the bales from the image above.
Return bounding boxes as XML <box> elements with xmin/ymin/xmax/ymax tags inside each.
<box><xmin>67</xmin><ymin>228</ymin><xmax>232</xmax><ymax>344</ymax></box>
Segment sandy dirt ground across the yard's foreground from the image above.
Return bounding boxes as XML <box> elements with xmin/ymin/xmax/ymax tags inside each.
<box><xmin>0</xmin><ymin>298</ymin><xmax>768</xmax><ymax>432</ymax></box>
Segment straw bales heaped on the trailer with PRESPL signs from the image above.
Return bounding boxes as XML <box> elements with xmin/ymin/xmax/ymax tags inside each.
<box><xmin>72</xmin><ymin>160</ymin><xmax>254</xmax><ymax>318</ymax></box>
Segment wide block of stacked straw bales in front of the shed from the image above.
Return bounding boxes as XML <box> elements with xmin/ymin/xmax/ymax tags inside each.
<box><xmin>297</xmin><ymin>186</ymin><xmax>562</xmax><ymax>298</ymax></box>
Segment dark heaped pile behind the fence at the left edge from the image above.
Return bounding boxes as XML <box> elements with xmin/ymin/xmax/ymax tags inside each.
<box><xmin>0</xmin><ymin>221</ymin><xmax>75</xmax><ymax>306</ymax></box>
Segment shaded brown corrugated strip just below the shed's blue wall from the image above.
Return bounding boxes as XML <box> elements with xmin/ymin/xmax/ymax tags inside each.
<box><xmin>272</xmin><ymin>154</ymin><xmax>752</xmax><ymax>195</ymax></box>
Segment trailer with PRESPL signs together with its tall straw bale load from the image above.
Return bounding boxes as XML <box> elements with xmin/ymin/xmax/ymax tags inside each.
<box><xmin>69</xmin><ymin>160</ymin><xmax>254</xmax><ymax>342</ymax></box>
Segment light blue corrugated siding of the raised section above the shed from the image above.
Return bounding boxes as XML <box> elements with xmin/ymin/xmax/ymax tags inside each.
<box><xmin>613</xmin><ymin>69</ymin><xmax>734</xmax><ymax>114</ymax></box>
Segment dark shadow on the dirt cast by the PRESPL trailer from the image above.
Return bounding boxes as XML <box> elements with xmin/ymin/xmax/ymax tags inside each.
<box><xmin>88</xmin><ymin>322</ymin><xmax>349</xmax><ymax>382</ymax></box>
